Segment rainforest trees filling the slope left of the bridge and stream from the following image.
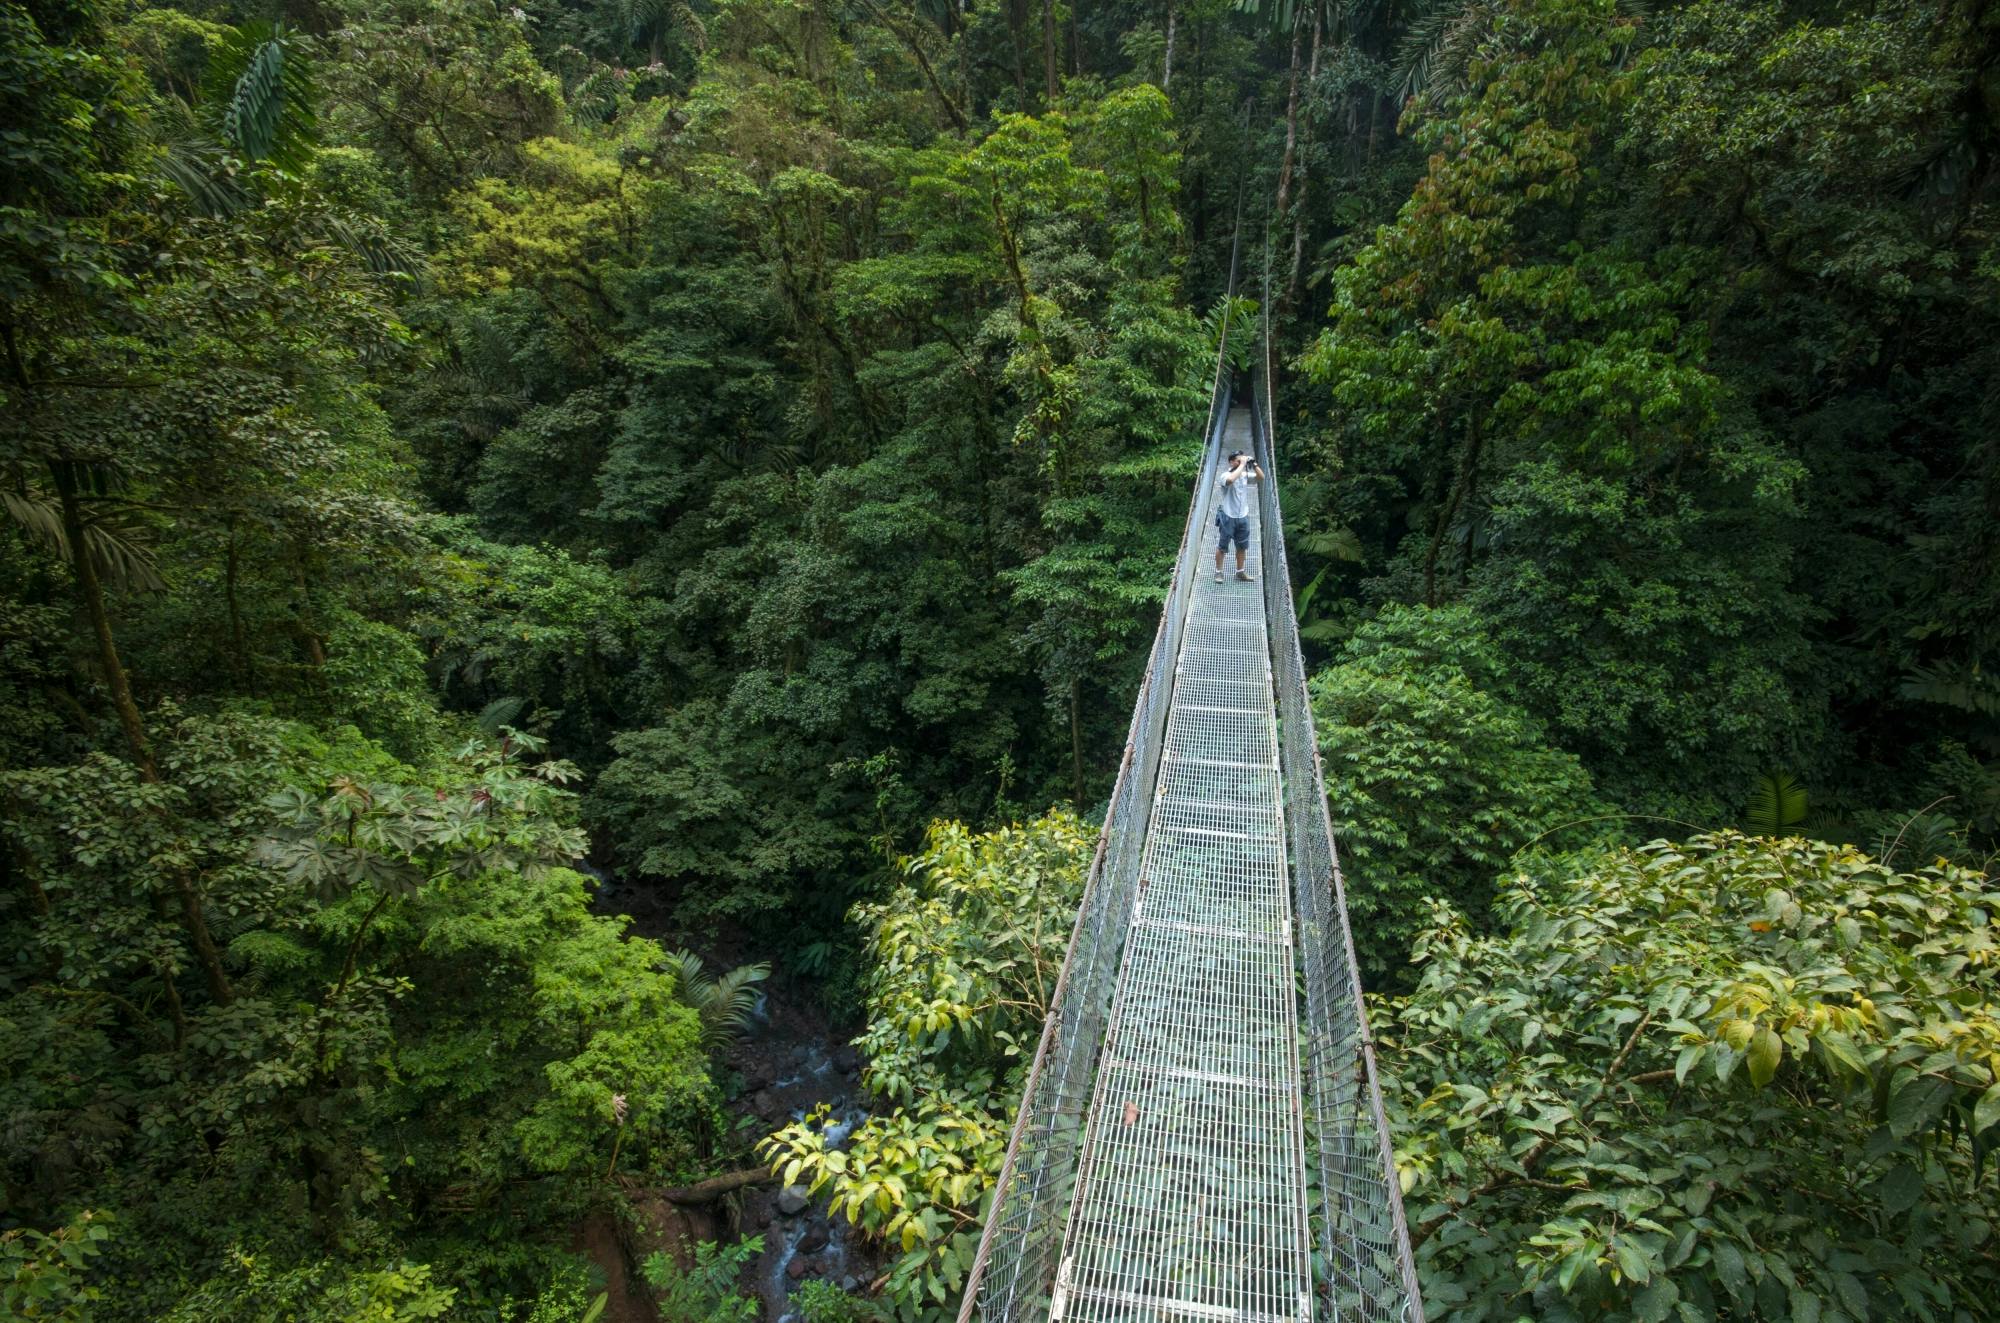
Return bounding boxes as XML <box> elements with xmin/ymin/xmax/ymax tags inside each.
<box><xmin>0</xmin><ymin>0</ymin><xmax>1208</xmax><ymax>1319</ymax></box>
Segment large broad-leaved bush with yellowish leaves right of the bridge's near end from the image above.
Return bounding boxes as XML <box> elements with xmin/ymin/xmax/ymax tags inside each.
<box><xmin>1384</xmin><ymin>835</ymin><xmax>2000</xmax><ymax>1321</ymax></box>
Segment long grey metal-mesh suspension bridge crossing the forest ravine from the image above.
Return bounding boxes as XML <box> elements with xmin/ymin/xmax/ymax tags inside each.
<box><xmin>958</xmin><ymin>277</ymin><xmax>1424</xmax><ymax>1323</ymax></box>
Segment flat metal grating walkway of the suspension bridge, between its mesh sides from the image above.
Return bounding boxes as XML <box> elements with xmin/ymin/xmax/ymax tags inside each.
<box><xmin>1050</xmin><ymin>410</ymin><xmax>1312</xmax><ymax>1323</ymax></box>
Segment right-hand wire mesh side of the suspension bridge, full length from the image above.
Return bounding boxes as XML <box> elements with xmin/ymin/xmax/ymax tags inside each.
<box><xmin>1258</xmin><ymin>377</ymin><xmax>1424</xmax><ymax>1323</ymax></box>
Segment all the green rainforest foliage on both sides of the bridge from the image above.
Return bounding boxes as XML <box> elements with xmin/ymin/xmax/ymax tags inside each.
<box><xmin>0</xmin><ymin>0</ymin><xmax>2000</xmax><ymax>1323</ymax></box>
